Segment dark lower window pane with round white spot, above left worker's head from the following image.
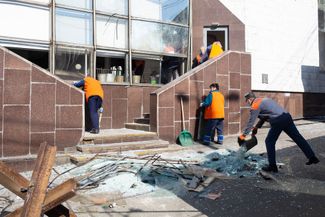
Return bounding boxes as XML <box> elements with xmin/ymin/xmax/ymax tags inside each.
<box><xmin>55</xmin><ymin>48</ymin><xmax>91</xmax><ymax>80</ymax></box>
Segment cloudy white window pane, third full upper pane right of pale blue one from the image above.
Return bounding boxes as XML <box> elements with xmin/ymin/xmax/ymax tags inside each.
<box><xmin>132</xmin><ymin>20</ymin><xmax>162</xmax><ymax>52</ymax></box>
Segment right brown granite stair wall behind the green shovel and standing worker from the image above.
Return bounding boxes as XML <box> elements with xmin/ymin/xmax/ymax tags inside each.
<box><xmin>150</xmin><ymin>51</ymin><xmax>250</xmax><ymax>142</ymax></box>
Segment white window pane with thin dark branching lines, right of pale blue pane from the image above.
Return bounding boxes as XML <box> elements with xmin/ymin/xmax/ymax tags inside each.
<box><xmin>96</xmin><ymin>16</ymin><xmax>128</xmax><ymax>48</ymax></box>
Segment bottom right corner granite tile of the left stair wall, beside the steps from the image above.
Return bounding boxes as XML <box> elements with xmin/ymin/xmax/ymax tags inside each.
<box><xmin>55</xmin><ymin>130</ymin><xmax>82</xmax><ymax>151</ymax></box>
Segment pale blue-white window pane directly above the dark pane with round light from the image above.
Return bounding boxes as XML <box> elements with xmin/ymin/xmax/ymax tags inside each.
<box><xmin>56</xmin><ymin>8</ymin><xmax>93</xmax><ymax>45</ymax></box>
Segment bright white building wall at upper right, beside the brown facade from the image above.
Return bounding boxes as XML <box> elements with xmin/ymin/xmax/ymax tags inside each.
<box><xmin>220</xmin><ymin>0</ymin><xmax>318</xmax><ymax>92</ymax></box>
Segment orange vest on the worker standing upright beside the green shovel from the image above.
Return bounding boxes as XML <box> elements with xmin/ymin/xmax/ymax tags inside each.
<box><xmin>204</xmin><ymin>91</ymin><xmax>225</xmax><ymax>119</ymax></box>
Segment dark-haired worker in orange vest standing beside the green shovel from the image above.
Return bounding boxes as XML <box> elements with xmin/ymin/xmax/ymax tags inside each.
<box><xmin>200</xmin><ymin>83</ymin><xmax>225</xmax><ymax>145</ymax></box>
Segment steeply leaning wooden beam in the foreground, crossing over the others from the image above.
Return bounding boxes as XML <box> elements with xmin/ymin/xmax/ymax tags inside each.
<box><xmin>21</xmin><ymin>142</ymin><xmax>56</xmax><ymax>217</ymax></box>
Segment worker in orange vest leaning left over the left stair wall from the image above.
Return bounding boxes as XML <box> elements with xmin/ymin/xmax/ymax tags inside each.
<box><xmin>73</xmin><ymin>76</ymin><xmax>104</xmax><ymax>134</ymax></box>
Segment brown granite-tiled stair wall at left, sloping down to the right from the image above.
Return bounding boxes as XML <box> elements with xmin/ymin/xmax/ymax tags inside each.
<box><xmin>0</xmin><ymin>47</ymin><xmax>84</xmax><ymax>157</ymax></box>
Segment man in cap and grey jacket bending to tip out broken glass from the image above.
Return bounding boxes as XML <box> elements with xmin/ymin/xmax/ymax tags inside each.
<box><xmin>238</xmin><ymin>91</ymin><xmax>319</xmax><ymax>172</ymax></box>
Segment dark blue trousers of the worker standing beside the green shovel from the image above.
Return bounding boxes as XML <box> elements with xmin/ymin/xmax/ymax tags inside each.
<box><xmin>203</xmin><ymin>119</ymin><xmax>223</xmax><ymax>143</ymax></box>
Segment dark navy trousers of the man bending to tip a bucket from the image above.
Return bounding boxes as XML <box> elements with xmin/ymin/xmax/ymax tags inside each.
<box><xmin>265</xmin><ymin>113</ymin><xmax>315</xmax><ymax>165</ymax></box>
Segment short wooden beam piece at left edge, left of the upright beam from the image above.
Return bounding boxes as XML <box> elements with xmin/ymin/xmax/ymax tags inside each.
<box><xmin>0</xmin><ymin>161</ymin><xmax>29</xmax><ymax>198</ymax></box>
